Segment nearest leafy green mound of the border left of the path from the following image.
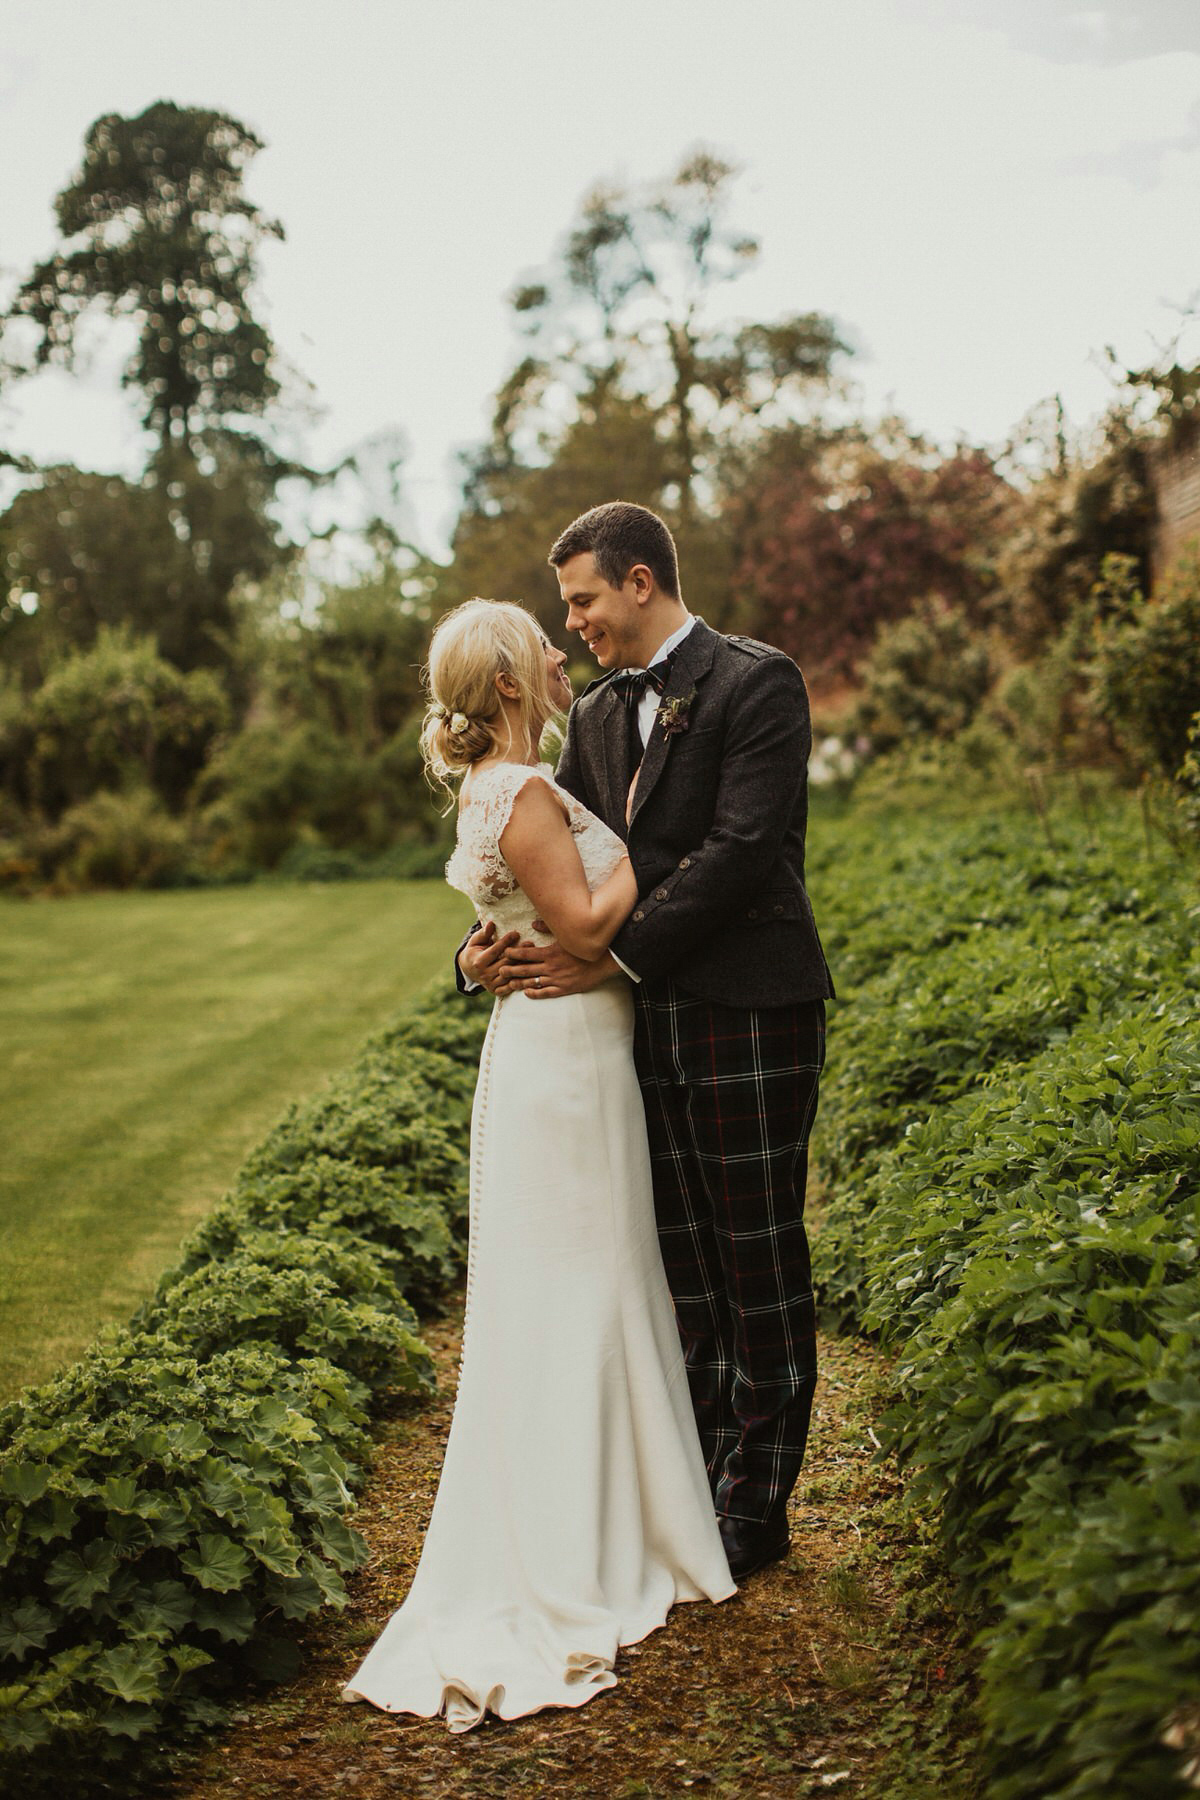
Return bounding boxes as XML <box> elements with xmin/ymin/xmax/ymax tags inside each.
<box><xmin>0</xmin><ymin>1332</ymin><xmax>365</xmax><ymax>1771</ymax></box>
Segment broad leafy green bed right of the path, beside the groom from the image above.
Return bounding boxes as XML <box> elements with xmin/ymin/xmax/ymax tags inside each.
<box><xmin>813</xmin><ymin>812</ymin><xmax>1200</xmax><ymax>1800</ymax></box>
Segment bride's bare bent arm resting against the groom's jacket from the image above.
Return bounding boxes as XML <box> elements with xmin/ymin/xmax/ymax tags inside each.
<box><xmin>500</xmin><ymin>781</ymin><xmax>637</xmax><ymax>963</ymax></box>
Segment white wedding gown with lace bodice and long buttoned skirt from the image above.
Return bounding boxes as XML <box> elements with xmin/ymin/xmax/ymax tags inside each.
<box><xmin>342</xmin><ymin>763</ymin><xmax>736</xmax><ymax>1732</ymax></box>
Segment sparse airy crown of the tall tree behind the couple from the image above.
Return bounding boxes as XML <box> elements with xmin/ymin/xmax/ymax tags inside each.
<box><xmin>468</xmin><ymin>149</ymin><xmax>847</xmax><ymax>527</ymax></box>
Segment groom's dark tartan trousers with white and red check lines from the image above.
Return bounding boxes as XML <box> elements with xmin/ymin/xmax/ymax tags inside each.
<box><xmin>633</xmin><ymin>981</ymin><xmax>826</xmax><ymax>1525</ymax></box>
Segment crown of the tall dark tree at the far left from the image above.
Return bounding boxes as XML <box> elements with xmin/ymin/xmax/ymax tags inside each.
<box><xmin>13</xmin><ymin>101</ymin><xmax>282</xmax><ymax>452</ymax></box>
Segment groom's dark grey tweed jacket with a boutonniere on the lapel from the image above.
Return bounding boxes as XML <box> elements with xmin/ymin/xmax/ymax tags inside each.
<box><xmin>558</xmin><ymin>619</ymin><xmax>833</xmax><ymax>1006</ymax></box>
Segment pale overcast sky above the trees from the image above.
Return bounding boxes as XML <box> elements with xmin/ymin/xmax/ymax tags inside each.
<box><xmin>0</xmin><ymin>0</ymin><xmax>1200</xmax><ymax>553</ymax></box>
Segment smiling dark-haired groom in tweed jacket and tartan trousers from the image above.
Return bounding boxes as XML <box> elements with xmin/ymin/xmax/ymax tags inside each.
<box><xmin>459</xmin><ymin>500</ymin><xmax>833</xmax><ymax>1579</ymax></box>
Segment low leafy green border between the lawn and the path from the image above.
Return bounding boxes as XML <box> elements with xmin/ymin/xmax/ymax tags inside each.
<box><xmin>0</xmin><ymin>994</ymin><xmax>488</xmax><ymax>1795</ymax></box>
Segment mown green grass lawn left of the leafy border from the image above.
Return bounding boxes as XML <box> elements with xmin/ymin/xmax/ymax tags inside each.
<box><xmin>0</xmin><ymin>880</ymin><xmax>470</xmax><ymax>1397</ymax></box>
